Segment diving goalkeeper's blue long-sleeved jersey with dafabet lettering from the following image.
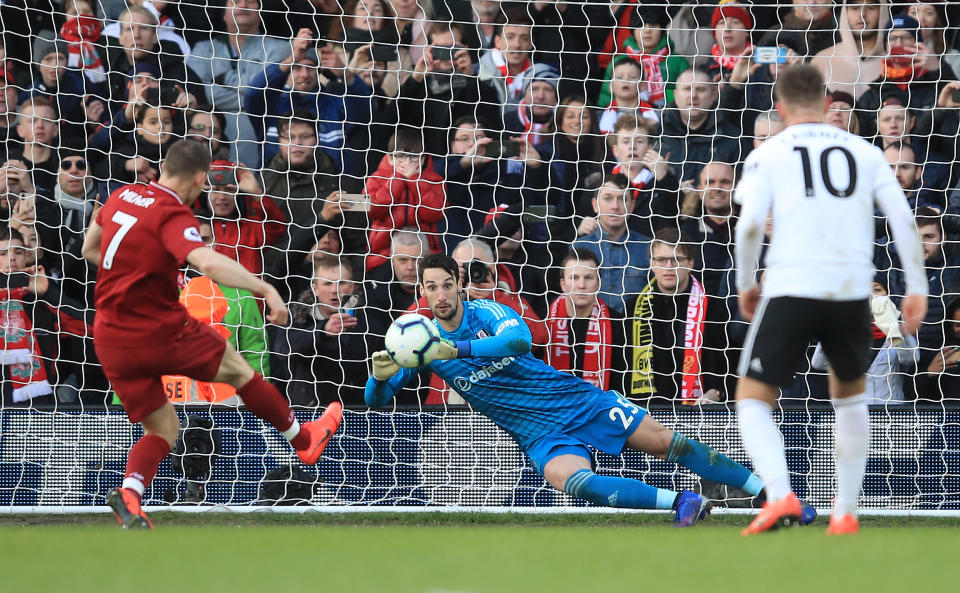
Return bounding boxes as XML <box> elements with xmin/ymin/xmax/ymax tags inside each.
<box><xmin>367</xmin><ymin>300</ymin><xmax>605</xmax><ymax>448</ymax></box>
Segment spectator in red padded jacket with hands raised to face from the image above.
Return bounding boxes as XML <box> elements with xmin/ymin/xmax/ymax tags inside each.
<box><xmin>367</xmin><ymin>127</ymin><xmax>447</xmax><ymax>270</ymax></box>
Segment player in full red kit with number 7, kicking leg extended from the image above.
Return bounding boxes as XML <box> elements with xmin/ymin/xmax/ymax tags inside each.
<box><xmin>83</xmin><ymin>140</ymin><xmax>343</xmax><ymax>529</ymax></box>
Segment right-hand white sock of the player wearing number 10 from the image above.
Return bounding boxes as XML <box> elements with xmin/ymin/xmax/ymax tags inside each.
<box><xmin>832</xmin><ymin>393</ymin><xmax>870</xmax><ymax>517</ymax></box>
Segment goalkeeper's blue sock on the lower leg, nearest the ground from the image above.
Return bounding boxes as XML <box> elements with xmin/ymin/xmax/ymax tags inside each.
<box><xmin>563</xmin><ymin>469</ymin><xmax>677</xmax><ymax>509</ymax></box>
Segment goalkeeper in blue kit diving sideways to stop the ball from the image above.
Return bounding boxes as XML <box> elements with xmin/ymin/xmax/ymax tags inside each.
<box><xmin>365</xmin><ymin>254</ymin><xmax>812</xmax><ymax>527</ymax></box>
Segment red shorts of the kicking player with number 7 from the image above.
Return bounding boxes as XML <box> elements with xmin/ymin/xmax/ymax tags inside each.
<box><xmin>93</xmin><ymin>318</ymin><xmax>227</xmax><ymax>423</ymax></box>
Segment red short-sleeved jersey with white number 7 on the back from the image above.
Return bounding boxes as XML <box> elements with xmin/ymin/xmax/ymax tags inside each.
<box><xmin>94</xmin><ymin>182</ymin><xmax>203</xmax><ymax>345</ymax></box>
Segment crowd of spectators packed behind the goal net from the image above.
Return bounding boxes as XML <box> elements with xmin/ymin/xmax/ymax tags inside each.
<box><xmin>0</xmin><ymin>0</ymin><xmax>960</xmax><ymax>409</ymax></box>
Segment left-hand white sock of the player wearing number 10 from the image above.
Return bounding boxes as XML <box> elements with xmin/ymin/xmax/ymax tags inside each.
<box><xmin>737</xmin><ymin>398</ymin><xmax>793</xmax><ymax>501</ymax></box>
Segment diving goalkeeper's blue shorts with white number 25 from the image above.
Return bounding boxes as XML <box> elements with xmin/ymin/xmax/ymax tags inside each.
<box><xmin>526</xmin><ymin>391</ymin><xmax>647</xmax><ymax>475</ymax></box>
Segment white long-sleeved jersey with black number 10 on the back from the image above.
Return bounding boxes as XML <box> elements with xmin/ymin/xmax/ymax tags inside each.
<box><xmin>734</xmin><ymin>124</ymin><xmax>927</xmax><ymax>301</ymax></box>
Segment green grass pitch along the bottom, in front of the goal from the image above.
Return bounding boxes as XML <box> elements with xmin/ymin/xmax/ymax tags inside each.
<box><xmin>0</xmin><ymin>512</ymin><xmax>960</xmax><ymax>593</ymax></box>
